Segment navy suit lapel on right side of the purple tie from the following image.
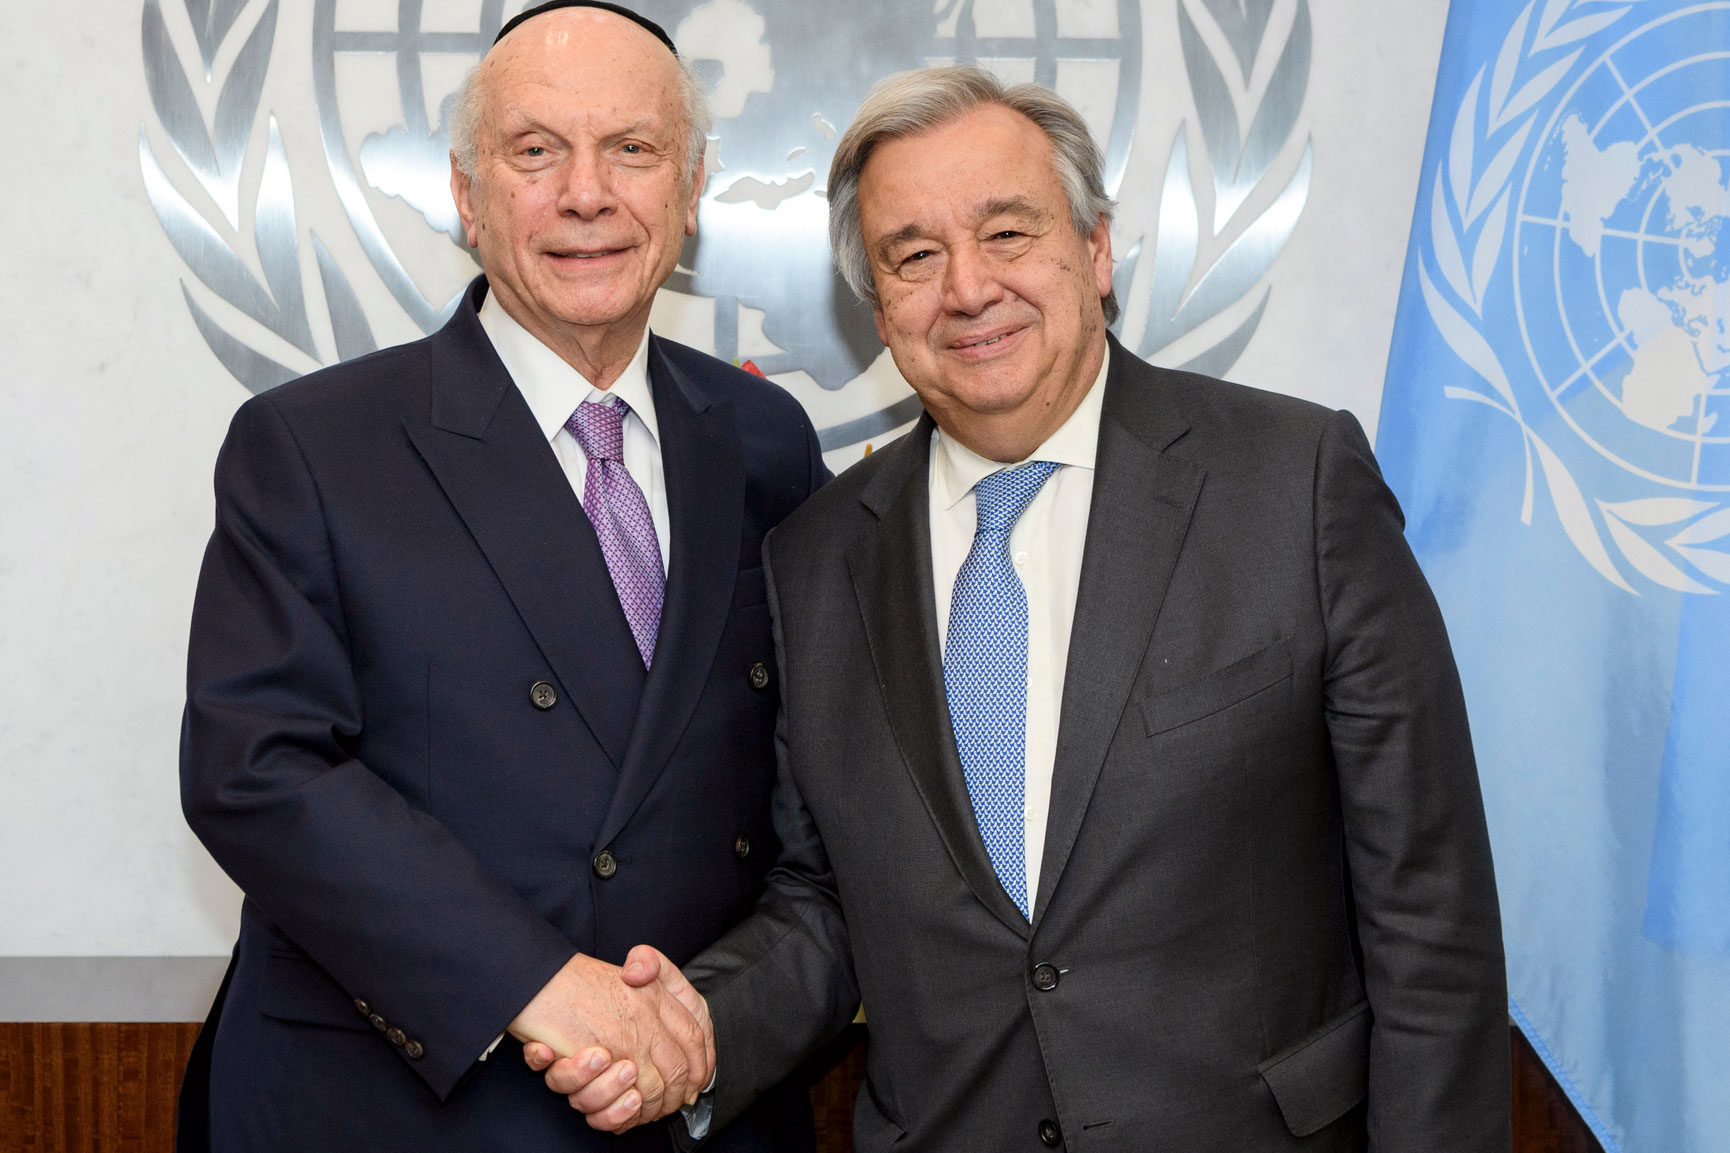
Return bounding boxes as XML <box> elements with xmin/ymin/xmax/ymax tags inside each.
<box><xmin>597</xmin><ymin>338</ymin><xmax>746</xmax><ymax>845</ymax></box>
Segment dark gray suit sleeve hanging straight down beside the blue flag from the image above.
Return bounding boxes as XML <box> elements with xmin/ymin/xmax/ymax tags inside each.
<box><xmin>1315</xmin><ymin>412</ymin><xmax>1512</xmax><ymax>1153</ymax></box>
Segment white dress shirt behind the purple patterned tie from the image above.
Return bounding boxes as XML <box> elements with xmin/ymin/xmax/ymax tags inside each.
<box><xmin>481</xmin><ymin>293</ymin><xmax>670</xmax><ymax>573</ymax></box>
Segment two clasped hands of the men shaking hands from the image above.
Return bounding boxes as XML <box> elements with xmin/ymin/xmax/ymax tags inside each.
<box><xmin>509</xmin><ymin>945</ymin><xmax>714</xmax><ymax>1132</ymax></box>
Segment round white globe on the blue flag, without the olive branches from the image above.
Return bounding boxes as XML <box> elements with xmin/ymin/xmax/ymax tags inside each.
<box><xmin>1514</xmin><ymin>3</ymin><xmax>1730</xmax><ymax>492</ymax></box>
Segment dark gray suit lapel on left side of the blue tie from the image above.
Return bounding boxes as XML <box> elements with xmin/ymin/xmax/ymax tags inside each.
<box><xmin>848</xmin><ymin>415</ymin><xmax>1028</xmax><ymax>937</ymax></box>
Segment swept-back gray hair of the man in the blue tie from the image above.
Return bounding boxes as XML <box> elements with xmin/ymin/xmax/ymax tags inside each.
<box><xmin>829</xmin><ymin>66</ymin><xmax>1118</xmax><ymax>324</ymax></box>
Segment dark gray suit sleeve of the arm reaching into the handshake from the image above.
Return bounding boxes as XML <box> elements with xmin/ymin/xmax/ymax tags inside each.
<box><xmin>675</xmin><ymin>529</ymin><xmax>860</xmax><ymax>1132</ymax></box>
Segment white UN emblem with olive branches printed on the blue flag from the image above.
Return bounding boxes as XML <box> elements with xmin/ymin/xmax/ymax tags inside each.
<box><xmin>1419</xmin><ymin>0</ymin><xmax>1730</xmax><ymax>594</ymax></box>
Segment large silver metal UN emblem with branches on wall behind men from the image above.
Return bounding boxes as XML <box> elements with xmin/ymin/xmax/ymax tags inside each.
<box><xmin>138</xmin><ymin>0</ymin><xmax>1311</xmax><ymax>450</ymax></box>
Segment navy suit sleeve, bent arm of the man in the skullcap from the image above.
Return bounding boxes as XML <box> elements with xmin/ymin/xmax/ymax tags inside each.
<box><xmin>180</xmin><ymin>396</ymin><xmax>574</xmax><ymax>1098</ymax></box>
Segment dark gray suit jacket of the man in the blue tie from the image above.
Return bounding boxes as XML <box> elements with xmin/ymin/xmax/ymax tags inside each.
<box><xmin>687</xmin><ymin>345</ymin><xmax>1510</xmax><ymax>1153</ymax></box>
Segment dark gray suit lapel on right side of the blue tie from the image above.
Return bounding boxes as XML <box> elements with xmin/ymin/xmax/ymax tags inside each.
<box><xmin>1035</xmin><ymin>341</ymin><xmax>1202</xmax><ymax>923</ymax></box>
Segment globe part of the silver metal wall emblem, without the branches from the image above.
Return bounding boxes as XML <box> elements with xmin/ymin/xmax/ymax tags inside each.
<box><xmin>313</xmin><ymin>0</ymin><xmax>1142</xmax><ymax>450</ymax></box>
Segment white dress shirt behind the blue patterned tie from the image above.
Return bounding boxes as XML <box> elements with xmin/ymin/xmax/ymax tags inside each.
<box><xmin>931</xmin><ymin>342</ymin><xmax>1111</xmax><ymax>907</ymax></box>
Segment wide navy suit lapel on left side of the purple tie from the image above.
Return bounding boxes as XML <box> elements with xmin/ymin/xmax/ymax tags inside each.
<box><xmin>403</xmin><ymin>282</ymin><xmax>644</xmax><ymax>765</ymax></box>
